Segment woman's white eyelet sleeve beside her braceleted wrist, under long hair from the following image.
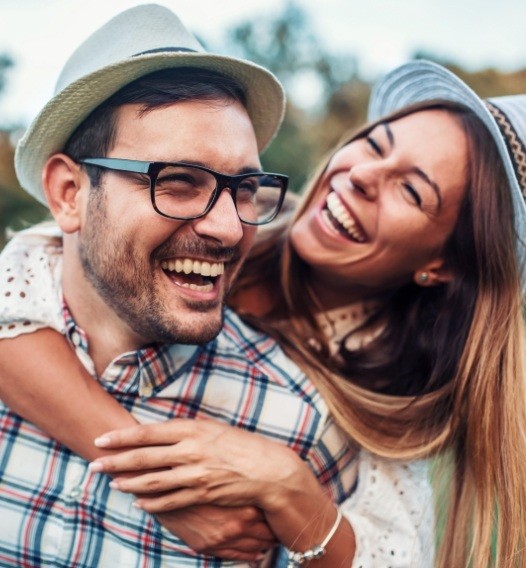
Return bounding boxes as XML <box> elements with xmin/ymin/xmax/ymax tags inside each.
<box><xmin>340</xmin><ymin>450</ymin><xmax>435</xmax><ymax>568</ymax></box>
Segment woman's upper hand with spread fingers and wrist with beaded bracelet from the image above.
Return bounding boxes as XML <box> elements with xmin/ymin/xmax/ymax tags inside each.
<box><xmin>91</xmin><ymin>420</ymin><xmax>355</xmax><ymax>568</ymax></box>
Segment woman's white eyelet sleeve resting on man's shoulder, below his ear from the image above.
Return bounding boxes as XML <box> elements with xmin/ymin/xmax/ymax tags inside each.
<box><xmin>0</xmin><ymin>223</ymin><xmax>64</xmax><ymax>339</ymax></box>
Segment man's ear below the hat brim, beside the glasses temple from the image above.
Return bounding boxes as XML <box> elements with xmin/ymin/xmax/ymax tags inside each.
<box><xmin>42</xmin><ymin>154</ymin><xmax>86</xmax><ymax>233</ymax></box>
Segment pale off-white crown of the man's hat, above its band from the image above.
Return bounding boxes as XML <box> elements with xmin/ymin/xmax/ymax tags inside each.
<box><xmin>55</xmin><ymin>4</ymin><xmax>205</xmax><ymax>94</ymax></box>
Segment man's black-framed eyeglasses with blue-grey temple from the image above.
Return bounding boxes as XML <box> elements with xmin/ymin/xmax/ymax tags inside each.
<box><xmin>77</xmin><ymin>158</ymin><xmax>288</xmax><ymax>225</ymax></box>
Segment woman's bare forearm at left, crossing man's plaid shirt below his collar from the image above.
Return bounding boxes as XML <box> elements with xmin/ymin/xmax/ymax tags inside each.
<box><xmin>0</xmin><ymin>328</ymin><xmax>137</xmax><ymax>460</ymax></box>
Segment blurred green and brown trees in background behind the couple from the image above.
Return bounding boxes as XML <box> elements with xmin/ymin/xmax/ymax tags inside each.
<box><xmin>0</xmin><ymin>1</ymin><xmax>526</xmax><ymax>247</ymax></box>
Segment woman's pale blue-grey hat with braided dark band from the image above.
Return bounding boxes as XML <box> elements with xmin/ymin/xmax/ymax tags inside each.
<box><xmin>368</xmin><ymin>60</ymin><xmax>526</xmax><ymax>288</ymax></box>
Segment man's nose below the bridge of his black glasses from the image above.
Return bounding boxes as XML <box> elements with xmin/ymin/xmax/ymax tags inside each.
<box><xmin>194</xmin><ymin>188</ymin><xmax>243</xmax><ymax>247</ymax></box>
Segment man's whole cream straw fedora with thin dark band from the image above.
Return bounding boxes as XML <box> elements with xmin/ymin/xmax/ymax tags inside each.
<box><xmin>15</xmin><ymin>4</ymin><xmax>285</xmax><ymax>205</ymax></box>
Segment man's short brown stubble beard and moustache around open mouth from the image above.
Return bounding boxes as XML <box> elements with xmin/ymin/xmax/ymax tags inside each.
<box><xmin>79</xmin><ymin>188</ymin><xmax>232</xmax><ymax>344</ymax></box>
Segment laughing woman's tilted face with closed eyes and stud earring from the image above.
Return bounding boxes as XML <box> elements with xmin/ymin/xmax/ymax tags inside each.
<box><xmin>291</xmin><ymin>110</ymin><xmax>468</xmax><ymax>305</ymax></box>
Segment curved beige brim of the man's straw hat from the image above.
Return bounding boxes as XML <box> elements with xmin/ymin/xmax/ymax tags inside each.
<box><xmin>15</xmin><ymin>52</ymin><xmax>285</xmax><ymax>206</ymax></box>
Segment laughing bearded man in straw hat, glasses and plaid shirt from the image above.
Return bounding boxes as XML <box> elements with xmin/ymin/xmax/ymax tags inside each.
<box><xmin>0</xmin><ymin>5</ymin><xmax>354</xmax><ymax>568</ymax></box>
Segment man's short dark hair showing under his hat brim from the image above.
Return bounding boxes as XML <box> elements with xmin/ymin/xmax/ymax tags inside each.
<box><xmin>64</xmin><ymin>67</ymin><xmax>250</xmax><ymax>187</ymax></box>
